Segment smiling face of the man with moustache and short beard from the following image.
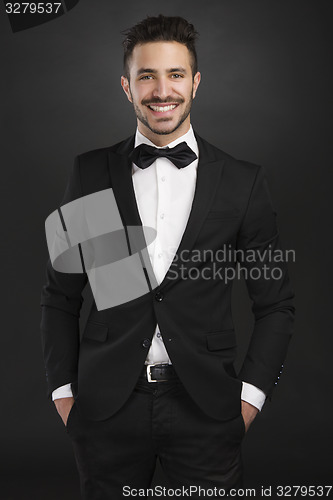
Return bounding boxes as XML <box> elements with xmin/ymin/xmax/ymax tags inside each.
<box><xmin>121</xmin><ymin>42</ymin><xmax>200</xmax><ymax>145</ymax></box>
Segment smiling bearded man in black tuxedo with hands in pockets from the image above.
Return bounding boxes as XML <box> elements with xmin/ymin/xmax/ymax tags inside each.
<box><xmin>42</xmin><ymin>15</ymin><xmax>294</xmax><ymax>500</ymax></box>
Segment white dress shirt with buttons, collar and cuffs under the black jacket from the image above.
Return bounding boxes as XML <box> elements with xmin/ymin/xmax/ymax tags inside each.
<box><xmin>52</xmin><ymin>126</ymin><xmax>266</xmax><ymax>410</ymax></box>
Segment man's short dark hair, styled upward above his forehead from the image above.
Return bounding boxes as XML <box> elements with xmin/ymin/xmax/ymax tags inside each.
<box><xmin>123</xmin><ymin>14</ymin><xmax>199</xmax><ymax>78</ymax></box>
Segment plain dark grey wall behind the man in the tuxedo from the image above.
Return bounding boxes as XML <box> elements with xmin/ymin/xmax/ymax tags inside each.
<box><xmin>0</xmin><ymin>0</ymin><xmax>332</xmax><ymax>500</ymax></box>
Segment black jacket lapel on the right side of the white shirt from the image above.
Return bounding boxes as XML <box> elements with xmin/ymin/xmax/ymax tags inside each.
<box><xmin>159</xmin><ymin>136</ymin><xmax>224</xmax><ymax>290</ymax></box>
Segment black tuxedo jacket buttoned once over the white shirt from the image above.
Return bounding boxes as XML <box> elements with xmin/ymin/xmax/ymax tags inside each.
<box><xmin>41</xmin><ymin>131</ymin><xmax>294</xmax><ymax>420</ymax></box>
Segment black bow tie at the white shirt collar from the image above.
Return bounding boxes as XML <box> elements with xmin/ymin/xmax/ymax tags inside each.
<box><xmin>130</xmin><ymin>141</ymin><xmax>197</xmax><ymax>168</ymax></box>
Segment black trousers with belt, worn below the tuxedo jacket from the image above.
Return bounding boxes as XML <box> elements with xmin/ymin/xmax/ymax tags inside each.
<box><xmin>67</xmin><ymin>376</ymin><xmax>245</xmax><ymax>500</ymax></box>
